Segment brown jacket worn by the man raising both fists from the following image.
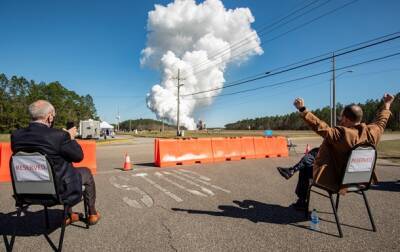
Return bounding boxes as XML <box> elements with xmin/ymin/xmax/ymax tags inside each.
<box><xmin>301</xmin><ymin>109</ymin><xmax>391</xmax><ymax>191</ymax></box>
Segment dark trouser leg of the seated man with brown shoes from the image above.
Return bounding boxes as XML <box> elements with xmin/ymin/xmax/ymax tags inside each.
<box><xmin>75</xmin><ymin>167</ymin><xmax>96</xmax><ymax>215</ymax></box>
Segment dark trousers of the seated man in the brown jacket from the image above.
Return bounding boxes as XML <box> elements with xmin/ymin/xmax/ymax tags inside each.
<box><xmin>293</xmin><ymin>148</ymin><xmax>319</xmax><ymax>202</ymax></box>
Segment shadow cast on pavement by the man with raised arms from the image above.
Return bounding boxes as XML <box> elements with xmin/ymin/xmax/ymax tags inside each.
<box><xmin>172</xmin><ymin>200</ymin><xmax>307</xmax><ymax>224</ymax></box>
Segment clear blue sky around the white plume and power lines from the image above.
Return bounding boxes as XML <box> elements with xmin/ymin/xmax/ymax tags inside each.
<box><xmin>0</xmin><ymin>0</ymin><xmax>400</xmax><ymax>127</ymax></box>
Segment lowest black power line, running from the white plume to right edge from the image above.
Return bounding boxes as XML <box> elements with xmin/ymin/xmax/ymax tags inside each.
<box><xmin>192</xmin><ymin>52</ymin><xmax>400</xmax><ymax>99</ymax></box>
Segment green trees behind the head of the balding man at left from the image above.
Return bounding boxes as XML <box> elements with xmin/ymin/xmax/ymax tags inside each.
<box><xmin>0</xmin><ymin>74</ymin><xmax>98</xmax><ymax>133</ymax></box>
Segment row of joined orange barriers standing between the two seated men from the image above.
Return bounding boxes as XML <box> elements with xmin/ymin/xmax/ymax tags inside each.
<box><xmin>154</xmin><ymin>137</ymin><xmax>288</xmax><ymax>167</ymax></box>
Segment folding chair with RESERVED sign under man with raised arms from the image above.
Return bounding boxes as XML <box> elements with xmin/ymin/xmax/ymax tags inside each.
<box><xmin>306</xmin><ymin>144</ymin><xmax>377</xmax><ymax>237</ymax></box>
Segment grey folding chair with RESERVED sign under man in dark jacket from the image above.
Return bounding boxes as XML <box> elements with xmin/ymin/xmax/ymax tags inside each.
<box><xmin>6</xmin><ymin>152</ymin><xmax>89</xmax><ymax>251</ymax></box>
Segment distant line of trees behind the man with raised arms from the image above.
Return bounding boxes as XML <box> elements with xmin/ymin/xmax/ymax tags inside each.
<box><xmin>225</xmin><ymin>93</ymin><xmax>400</xmax><ymax>130</ymax></box>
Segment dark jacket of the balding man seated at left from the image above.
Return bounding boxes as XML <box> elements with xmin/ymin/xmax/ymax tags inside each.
<box><xmin>11</xmin><ymin>122</ymin><xmax>83</xmax><ymax>206</ymax></box>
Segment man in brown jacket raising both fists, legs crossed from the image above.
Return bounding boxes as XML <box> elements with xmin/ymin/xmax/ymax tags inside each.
<box><xmin>278</xmin><ymin>94</ymin><xmax>394</xmax><ymax>210</ymax></box>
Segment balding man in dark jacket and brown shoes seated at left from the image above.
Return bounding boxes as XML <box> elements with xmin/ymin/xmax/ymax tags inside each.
<box><xmin>11</xmin><ymin>100</ymin><xmax>100</xmax><ymax>225</ymax></box>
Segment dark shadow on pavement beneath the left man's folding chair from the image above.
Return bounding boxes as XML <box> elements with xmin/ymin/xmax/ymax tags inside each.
<box><xmin>0</xmin><ymin>209</ymin><xmax>63</xmax><ymax>251</ymax></box>
